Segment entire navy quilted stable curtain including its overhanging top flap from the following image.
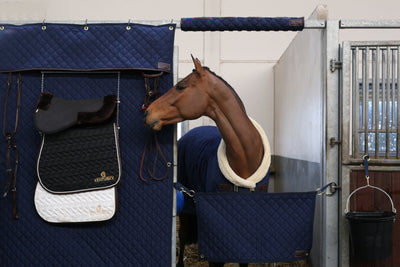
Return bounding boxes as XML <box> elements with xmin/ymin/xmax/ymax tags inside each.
<box><xmin>0</xmin><ymin>24</ymin><xmax>175</xmax><ymax>266</ymax></box>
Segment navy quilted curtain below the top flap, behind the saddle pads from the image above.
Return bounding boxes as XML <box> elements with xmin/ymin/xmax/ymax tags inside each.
<box><xmin>0</xmin><ymin>23</ymin><xmax>173</xmax><ymax>266</ymax></box>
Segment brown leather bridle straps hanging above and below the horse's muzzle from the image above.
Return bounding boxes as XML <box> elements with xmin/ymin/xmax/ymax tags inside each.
<box><xmin>139</xmin><ymin>72</ymin><xmax>172</xmax><ymax>182</ymax></box>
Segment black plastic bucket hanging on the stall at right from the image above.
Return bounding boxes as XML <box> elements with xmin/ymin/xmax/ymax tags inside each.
<box><xmin>346</xmin><ymin>211</ymin><xmax>396</xmax><ymax>260</ymax></box>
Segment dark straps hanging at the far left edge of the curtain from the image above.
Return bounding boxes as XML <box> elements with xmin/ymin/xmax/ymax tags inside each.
<box><xmin>3</xmin><ymin>73</ymin><xmax>22</xmax><ymax>219</ymax></box>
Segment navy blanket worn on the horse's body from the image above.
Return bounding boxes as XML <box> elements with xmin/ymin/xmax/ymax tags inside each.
<box><xmin>178</xmin><ymin>126</ymin><xmax>269</xmax><ymax>213</ymax></box>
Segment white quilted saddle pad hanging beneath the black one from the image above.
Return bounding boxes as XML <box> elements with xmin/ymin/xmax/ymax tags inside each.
<box><xmin>34</xmin><ymin>183</ymin><xmax>117</xmax><ymax>223</ymax></box>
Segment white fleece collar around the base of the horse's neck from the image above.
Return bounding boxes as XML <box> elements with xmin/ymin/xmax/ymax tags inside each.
<box><xmin>217</xmin><ymin>118</ymin><xmax>271</xmax><ymax>189</ymax></box>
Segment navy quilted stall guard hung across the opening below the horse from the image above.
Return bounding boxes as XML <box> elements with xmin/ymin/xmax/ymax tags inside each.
<box><xmin>195</xmin><ymin>192</ymin><xmax>316</xmax><ymax>262</ymax></box>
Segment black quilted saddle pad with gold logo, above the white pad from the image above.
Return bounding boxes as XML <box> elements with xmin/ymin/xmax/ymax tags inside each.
<box><xmin>37</xmin><ymin>123</ymin><xmax>120</xmax><ymax>193</ymax></box>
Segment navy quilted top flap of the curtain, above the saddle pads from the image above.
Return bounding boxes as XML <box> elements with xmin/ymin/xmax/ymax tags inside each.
<box><xmin>0</xmin><ymin>24</ymin><xmax>175</xmax><ymax>71</ymax></box>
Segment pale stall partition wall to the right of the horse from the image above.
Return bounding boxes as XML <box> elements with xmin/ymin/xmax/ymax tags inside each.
<box><xmin>273</xmin><ymin>26</ymin><xmax>325</xmax><ymax>266</ymax></box>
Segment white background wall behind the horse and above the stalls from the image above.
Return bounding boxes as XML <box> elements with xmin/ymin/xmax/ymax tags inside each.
<box><xmin>0</xmin><ymin>0</ymin><xmax>400</xmax><ymax>153</ymax></box>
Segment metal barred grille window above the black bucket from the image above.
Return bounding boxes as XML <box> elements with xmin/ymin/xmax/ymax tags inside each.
<box><xmin>350</xmin><ymin>43</ymin><xmax>400</xmax><ymax>159</ymax></box>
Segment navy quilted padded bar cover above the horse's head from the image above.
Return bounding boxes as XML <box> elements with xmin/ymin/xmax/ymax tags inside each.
<box><xmin>181</xmin><ymin>17</ymin><xmax>304</xmax><ymax>31</ymax></box>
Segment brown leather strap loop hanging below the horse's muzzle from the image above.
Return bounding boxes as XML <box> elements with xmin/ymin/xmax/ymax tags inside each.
<box><xmin>139</xmin><ymin>132</ymin><xmax>171</xmax><ymax>182</ymax></box>
